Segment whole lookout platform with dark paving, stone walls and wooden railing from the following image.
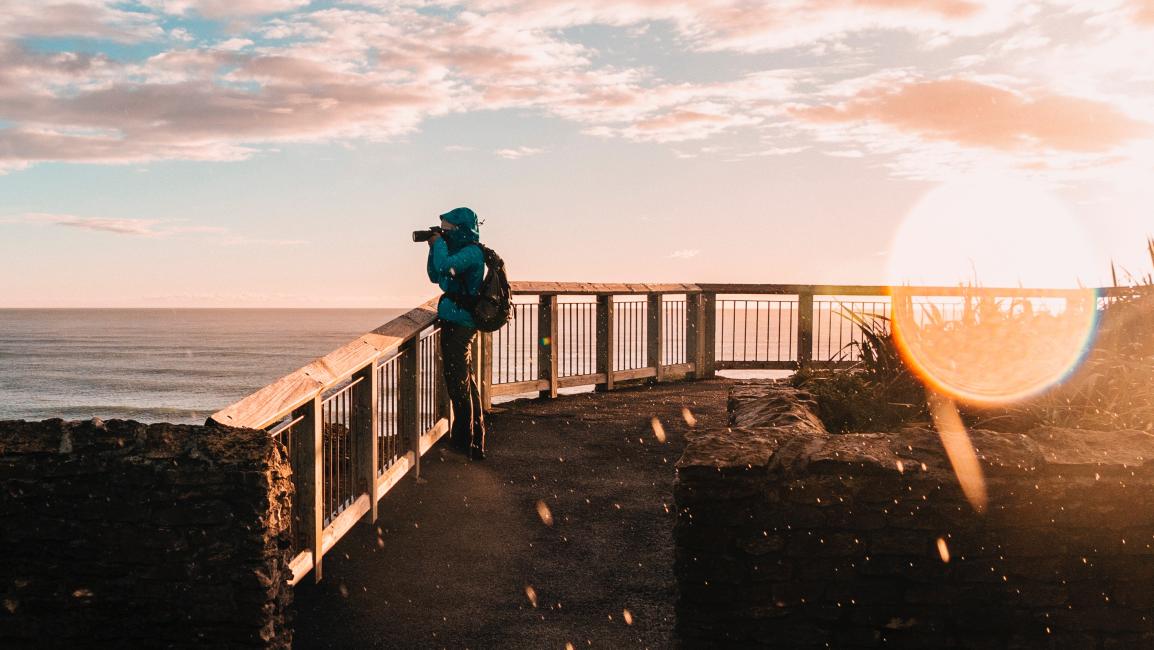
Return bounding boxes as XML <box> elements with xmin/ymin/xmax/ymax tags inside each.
<box><xmin>0</xmin><ymin>283</ymin><xmax>1154</xmax><ymax>649</ymax></box>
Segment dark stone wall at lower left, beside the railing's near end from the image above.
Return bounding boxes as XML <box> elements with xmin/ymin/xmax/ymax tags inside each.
<box><xmin>0</xmin><ymin>420</ymin><xmax>292</xmax><ymax>648</ymax></box>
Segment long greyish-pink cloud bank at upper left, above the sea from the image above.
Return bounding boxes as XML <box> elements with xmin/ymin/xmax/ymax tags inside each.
<box><xmin>0</xmin><ymin>44</ymin><xmax>449</xmax><ymax>166</ymax></box>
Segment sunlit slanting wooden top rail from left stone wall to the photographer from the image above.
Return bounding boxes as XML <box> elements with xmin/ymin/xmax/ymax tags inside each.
<box><xmin>210</xmin><ymin>298</ymin><xmax>437</xmax><ymax>428</ymax></box>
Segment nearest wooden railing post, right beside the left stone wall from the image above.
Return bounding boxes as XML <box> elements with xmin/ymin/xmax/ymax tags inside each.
<box><xmin>292</xmin><ymin>394</ymin><xmax>324</xmax><ymax>582</ymax></box>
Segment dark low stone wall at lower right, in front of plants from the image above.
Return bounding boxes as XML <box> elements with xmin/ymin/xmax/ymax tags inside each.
<box><xmin>675</xmin><ymin>383</ymin><xmax>1154</xmax><ymax>648</ymax></box>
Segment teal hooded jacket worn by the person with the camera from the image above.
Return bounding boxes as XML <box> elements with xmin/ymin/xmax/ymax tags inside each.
<box><xmin>426</xmin><ymin>208</ymin><xmax>485</xmax><ymax>329</ymax></box>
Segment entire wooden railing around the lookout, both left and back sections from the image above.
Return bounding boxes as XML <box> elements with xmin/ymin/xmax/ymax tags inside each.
<box><xmin>210</xmin><ymin>282</ymin><xmax>1131</xmax><ymax>584</ymax></box>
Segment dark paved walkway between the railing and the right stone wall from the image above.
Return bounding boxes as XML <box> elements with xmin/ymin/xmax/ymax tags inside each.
<box><xmin>295</xmin><ymin>380</ymin><xmax>728</xmax><ymax>650</ymax></box>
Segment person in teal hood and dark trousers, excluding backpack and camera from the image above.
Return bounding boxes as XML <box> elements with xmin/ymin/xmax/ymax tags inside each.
<box><xmin>427</xmin><ymin>208</ymin><xmax>485</xmax><ymax>461</ymax></box>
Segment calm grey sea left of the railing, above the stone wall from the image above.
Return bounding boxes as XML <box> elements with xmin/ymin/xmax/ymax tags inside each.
<box><xmin>0</xmin><ymin>309</ymin><xmax>406</xmax><ymax>424</ymax></box>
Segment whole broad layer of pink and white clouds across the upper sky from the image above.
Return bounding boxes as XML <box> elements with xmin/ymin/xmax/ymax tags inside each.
<box><xmin>0</xmin><ymin>0</ymin><xmax>1154</xmax><ymax>182</ymax></box>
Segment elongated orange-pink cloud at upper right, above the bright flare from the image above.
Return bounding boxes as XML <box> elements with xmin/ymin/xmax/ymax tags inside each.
<box><xmin>793</xmin><ymin>80</ymin><xmax>1151</xmax><ymax>152</ymax></box>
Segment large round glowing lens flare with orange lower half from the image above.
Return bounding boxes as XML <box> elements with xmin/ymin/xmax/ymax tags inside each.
<box><xmin>889</xmin><ymin>178</ymin><xmax>1096</xmax><ymax>403</ymax></box>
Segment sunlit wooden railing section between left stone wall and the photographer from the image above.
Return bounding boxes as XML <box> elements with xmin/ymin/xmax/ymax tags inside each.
<box><xmin>210</xmin><ymin>300</ymin><xmax>449</xmax><ymax>584</ymax></box>
